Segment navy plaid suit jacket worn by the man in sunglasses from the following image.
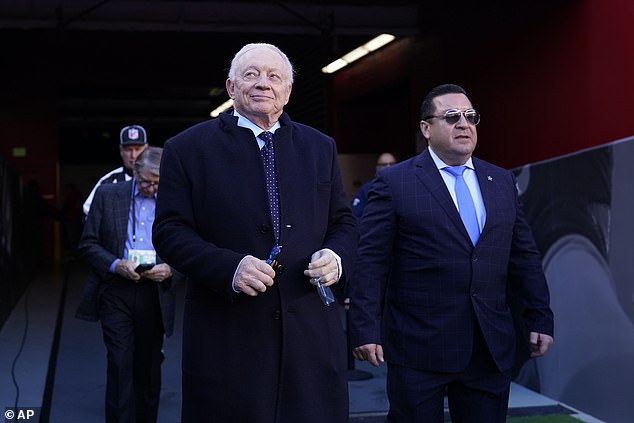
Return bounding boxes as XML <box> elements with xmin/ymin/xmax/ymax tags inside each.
<box><xmin>350</xmin><ymin>150</ymin><xmax>553</xmax><ymax>372</ymax></box>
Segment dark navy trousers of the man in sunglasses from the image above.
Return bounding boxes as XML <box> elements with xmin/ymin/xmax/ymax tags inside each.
<box><xmin>387</xmin><ymin>327</ymin><xmax>511</xmax><ymax>423</ymax></box>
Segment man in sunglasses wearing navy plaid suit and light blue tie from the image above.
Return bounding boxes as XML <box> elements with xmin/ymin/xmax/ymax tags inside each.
<box><xmin>350</xmin><ymin>84</ymin><xmax>553</xmax><ymax>423</ymax></box>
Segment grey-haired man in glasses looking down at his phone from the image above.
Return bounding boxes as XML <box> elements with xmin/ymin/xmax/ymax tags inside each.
<box><xmin>76</xmin><ymin>147</ymin><xmax>175</xmax><ymax>423</ymax></box>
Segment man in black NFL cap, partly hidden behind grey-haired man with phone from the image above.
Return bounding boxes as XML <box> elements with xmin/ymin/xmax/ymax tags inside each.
<box><xmin>83</xmin><ymin>125</ymin><xmax>148</xmax><ymax>216</ymax></box>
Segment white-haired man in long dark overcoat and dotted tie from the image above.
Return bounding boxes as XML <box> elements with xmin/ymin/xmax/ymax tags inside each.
<box><xmin>149</xmin><ymin>44</ymin><xmax>357</xmax><ymax>423</ymax></box>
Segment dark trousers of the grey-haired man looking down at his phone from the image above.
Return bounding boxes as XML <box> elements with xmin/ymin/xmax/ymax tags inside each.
<box><xmin>99</xmin><ymin>278</ymin><xmax>164</xmax><ymax>423</ymax></box>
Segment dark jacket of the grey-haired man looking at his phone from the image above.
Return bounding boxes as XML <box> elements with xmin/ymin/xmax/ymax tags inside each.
<box><xmin>76</xmin><ymin>181</ymin><xmax>176</xmax><ymax>336</ymax></box>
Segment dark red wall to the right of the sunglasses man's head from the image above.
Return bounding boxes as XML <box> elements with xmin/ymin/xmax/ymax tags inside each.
<box><xmin>471</xmin><ymin>0</ymin><xmax>634</xmax><ymax>167</ymax></box>
